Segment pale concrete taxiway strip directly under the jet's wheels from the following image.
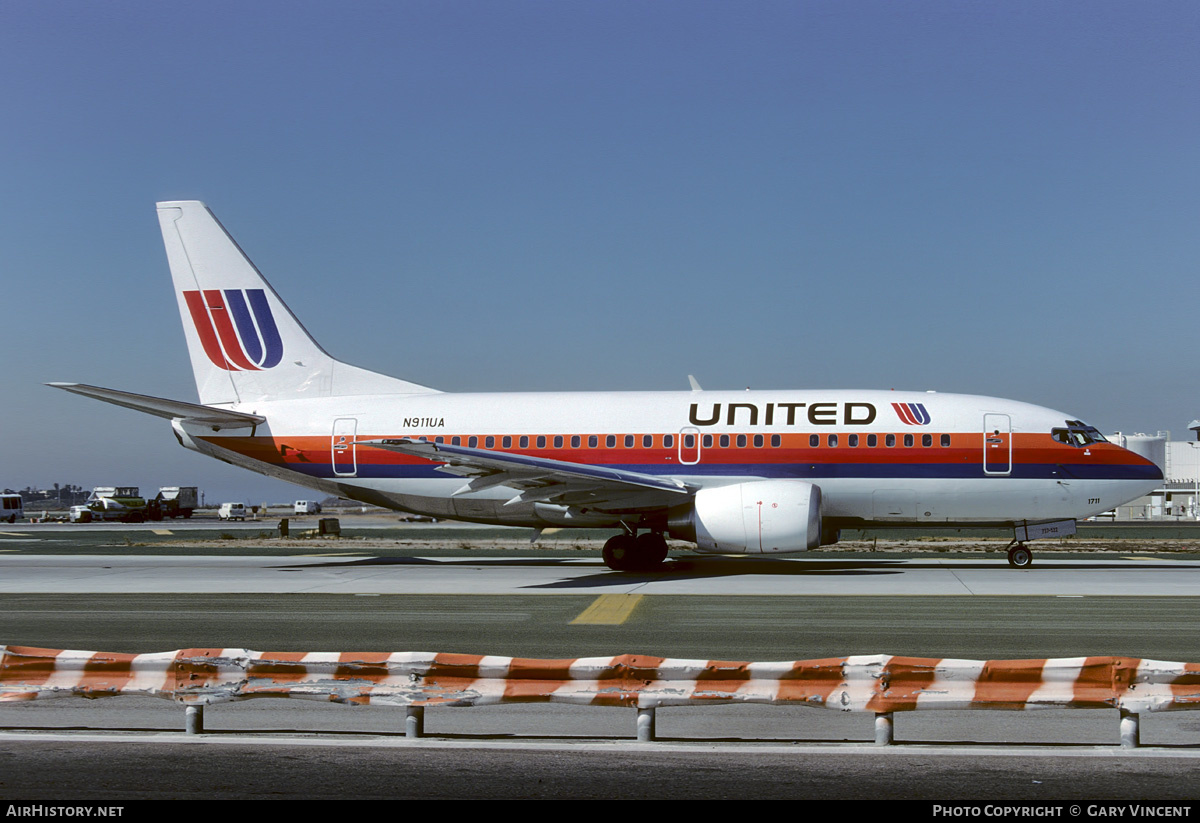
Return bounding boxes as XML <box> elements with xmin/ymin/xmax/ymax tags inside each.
<box><xmin>0</xmin><ymin>546</ymin><xmax>1200</xmax><ymax>597</ymax></box>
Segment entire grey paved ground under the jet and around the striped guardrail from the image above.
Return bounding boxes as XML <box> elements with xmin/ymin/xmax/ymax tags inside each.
<box><xmin>0</xmin><ymin>527</ymin><xmax>1200</xmax><ymax>799</ymax></box>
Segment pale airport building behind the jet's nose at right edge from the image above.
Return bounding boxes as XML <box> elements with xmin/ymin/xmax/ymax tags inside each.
<box><xmin>1096</xmin><ymin>420</ymin><xmax>1200</xmax><ymax>521</ymax></box>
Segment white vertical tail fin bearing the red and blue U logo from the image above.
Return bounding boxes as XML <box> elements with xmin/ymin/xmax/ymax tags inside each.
<box><xmin>158</xmin><ymin>200</ymin><xmax>436</xmax><ymax>404</ymax></box>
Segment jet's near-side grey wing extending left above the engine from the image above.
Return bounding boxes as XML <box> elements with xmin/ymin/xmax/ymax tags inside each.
<box><xmin>356</xmin><ymin>438</ymin><xmax>696</xmax><ymax>511</ymax></box>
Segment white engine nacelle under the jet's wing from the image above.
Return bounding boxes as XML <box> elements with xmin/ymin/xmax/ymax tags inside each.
<box><xmin>668</xmin><ymin>480</ymin><xmax>821</xmax><ymax>554</ymax></box>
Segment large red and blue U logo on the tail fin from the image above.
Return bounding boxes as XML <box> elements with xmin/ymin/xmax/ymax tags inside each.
<box><xmin>184</xmin><ymin>289</ymin><xmax>283</xmax><ymax>372</ymax></box>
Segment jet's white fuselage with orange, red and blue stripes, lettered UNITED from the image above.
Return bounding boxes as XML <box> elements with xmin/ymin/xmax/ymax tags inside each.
<box><xmin>176</xmin><ymin>390</ymin><xmax>1162</xmax><ymax>537</ymax></box>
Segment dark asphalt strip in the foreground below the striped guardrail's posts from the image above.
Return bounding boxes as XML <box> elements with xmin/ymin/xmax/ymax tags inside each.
<box><xmin>7</xmin><ymin>738</ymin><xmax>1198</xmax><ymax>801</ymax></box>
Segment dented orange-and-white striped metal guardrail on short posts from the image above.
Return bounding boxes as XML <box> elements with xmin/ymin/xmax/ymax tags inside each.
<box><xmin>0</xmin><ymin>645</ymin><xmax>1200</xmax><ymax>747</ymax></box>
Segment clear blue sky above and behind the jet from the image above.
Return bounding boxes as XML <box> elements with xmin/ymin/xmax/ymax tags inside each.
<box><xmin>0</xmin><ymin>0</ymin><xmax>1200</xmax><ymax>501</ymax></box>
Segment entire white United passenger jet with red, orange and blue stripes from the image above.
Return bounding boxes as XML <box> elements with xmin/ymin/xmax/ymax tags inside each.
<box><xmin>50</xmin><ymin>200</ymin><xmax>1163</xmax><ymax>570</ymax></box>
